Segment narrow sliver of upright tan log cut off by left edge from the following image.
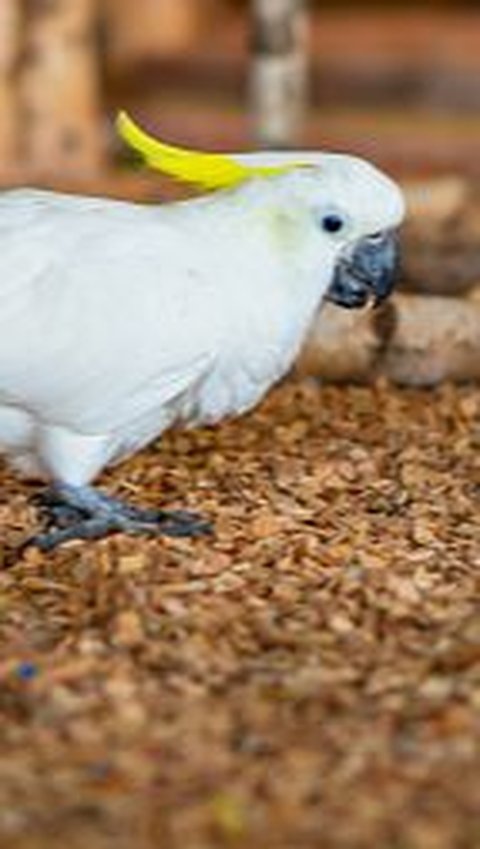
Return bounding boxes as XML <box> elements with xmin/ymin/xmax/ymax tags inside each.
<box><xmin>0</xmin><ymin>0</ymin><xmax>21</xmax><ymax>175</ymax></box>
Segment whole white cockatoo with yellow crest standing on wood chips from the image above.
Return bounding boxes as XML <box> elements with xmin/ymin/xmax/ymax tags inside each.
<box><xmin>0</xmin><ymin>113</ymin><xmax>404</xmax><ymax>549</ymax></box>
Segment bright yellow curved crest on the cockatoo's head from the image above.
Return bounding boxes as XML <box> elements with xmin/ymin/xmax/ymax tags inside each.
<box><xmin>117</xmin><ymin>112</ymin><xmax>298</xmax><ymax>189</ymax></box>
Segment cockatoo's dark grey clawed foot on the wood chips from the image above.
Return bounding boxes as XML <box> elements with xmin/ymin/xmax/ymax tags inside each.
<box><xmin>29</xmin><ymin>483</ymin><xmax>211</xmax><ymax>551</ymax></box>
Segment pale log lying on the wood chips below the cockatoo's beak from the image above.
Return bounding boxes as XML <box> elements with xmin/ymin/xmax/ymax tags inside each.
<box><xmin>297</xmin><ymin>290</ymin><xmax>480</xmax><ymax>386</ymax></box>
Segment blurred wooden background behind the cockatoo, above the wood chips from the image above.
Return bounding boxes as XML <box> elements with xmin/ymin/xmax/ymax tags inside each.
<box><xmin>0</xmin><ymin>0</ymin><xmax>480</xmax><ymax>385</ymax></box>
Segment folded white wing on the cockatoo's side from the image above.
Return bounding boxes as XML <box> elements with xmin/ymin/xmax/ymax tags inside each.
<box><xmin>0</xmin><ymin>190</ymin><xmax>214</xmax><ymax>433</ymax></box>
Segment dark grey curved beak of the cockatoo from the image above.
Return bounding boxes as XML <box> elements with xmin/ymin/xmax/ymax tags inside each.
<box><xmin>326</xmin><ymin>230</ymin><xmax>398</xmax><ymax>309</ymax></box>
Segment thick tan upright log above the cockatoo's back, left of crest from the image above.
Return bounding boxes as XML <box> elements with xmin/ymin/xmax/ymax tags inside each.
<box><xmin>20</xmin><ymin>0</ymin><xmax>102</xmax><ymax>176</ymax></box>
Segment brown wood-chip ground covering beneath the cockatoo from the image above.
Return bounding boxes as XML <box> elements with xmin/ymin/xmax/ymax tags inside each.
<box><xmin>0</xmin><ymin>382</ymin><xmax>480</xmax><ymax>849</ymax></box>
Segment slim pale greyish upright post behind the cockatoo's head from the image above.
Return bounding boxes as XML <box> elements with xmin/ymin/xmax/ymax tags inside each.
<box><xmin>250</xmin><ymin>0</ymin><xmax>308</xmax><ymax>148</ymax></box>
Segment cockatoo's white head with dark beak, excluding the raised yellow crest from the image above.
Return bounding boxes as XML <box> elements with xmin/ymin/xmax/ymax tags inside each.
<box><xmin>246</xmin><ymin>152</ymin><xmax>405</xmax><ymax>308</ymax></box>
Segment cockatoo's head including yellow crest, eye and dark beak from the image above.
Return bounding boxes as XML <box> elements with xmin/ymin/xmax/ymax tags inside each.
<box><xmin>117</xmin><ymin>113</ymin><xmax>405</xmax><ymax>308</ymax></box>
